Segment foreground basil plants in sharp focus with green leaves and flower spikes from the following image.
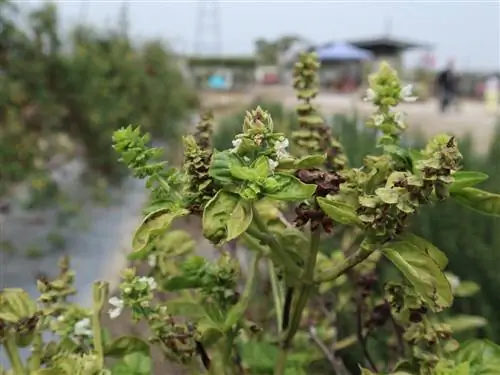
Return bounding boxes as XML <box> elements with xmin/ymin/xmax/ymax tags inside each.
<box><xmin>0</xmin><ymin>54</ymin><xmax>500</xmax><ymax>375</ymax></box>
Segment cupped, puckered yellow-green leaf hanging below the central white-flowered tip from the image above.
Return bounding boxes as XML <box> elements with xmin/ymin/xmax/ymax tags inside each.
<box><xmin>202</xmin><ymin>191</ymin><xmax>252</xmax><ymax>245</ymax></box>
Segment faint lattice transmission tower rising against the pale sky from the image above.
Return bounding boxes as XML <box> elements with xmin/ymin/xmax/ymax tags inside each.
<box><xmin>193</xmin><ymin>0</ymin><xmax>222</xmax><ymax>56</ymax></box>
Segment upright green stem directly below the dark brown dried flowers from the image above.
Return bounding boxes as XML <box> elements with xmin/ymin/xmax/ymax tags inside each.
<box><xmin>284</xmin><ymin>229</ymin><xmax>321</xmax><ymax>347</ymax></box>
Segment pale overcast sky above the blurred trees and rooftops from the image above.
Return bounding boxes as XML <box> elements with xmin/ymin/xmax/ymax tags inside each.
<box><xmin>27</xmin><ymin>0</ymin><xmax>500</xmax><ymax>70</ymax></box>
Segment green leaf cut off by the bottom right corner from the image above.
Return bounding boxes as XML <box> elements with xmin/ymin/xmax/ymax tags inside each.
<box><xmin>454</xmin><ymin>340</ymin><xmax>500</xmax><ymax>375</ymax></box>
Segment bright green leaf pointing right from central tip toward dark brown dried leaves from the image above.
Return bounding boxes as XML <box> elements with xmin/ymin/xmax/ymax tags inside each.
<box><xmin>263</xmin><ymin>173</ymin><xmax>316</xmax><ymax>201</ymax></box>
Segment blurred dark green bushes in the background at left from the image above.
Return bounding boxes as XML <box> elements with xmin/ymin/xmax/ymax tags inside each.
<box><xmin>0</xmin><ymin>1</ymin><xmax>196</xmax><ymax>193</ymax></box>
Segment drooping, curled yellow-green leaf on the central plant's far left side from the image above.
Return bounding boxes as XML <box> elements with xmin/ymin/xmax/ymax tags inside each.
<box><xmin>129</xmin><ymin>208</ymin><xmax>189</xmax><ymax>260</ymax></box>
